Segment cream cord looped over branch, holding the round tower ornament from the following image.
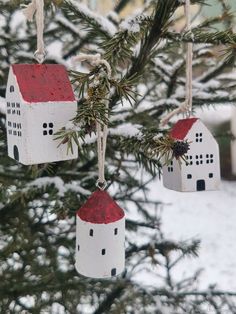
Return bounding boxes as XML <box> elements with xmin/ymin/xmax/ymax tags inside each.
<box><xmin>73</xmin><ymin>54</ymin><xmax>112</xmax><ymax>190</ymax></box>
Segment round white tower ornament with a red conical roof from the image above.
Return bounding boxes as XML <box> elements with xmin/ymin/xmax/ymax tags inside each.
<box><xmin>75</xmin><ymin>190</ymin><xmax>125</xmax><ymax>278</ymax></box>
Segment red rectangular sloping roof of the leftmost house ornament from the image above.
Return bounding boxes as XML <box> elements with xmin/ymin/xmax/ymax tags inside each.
<box><xmin>12</xmin><ymin>64</ymin><xmax>75</xmax><ymax>103</ymax></box>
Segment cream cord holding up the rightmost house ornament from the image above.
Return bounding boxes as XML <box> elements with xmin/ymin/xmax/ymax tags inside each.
<box><xmin>161</xmin><ymin>0</ymin><xmax>193</xmax><ymax>125</ymax></box>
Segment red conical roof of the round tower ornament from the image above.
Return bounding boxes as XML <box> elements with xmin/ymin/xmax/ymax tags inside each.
<box><xmin>77</xmin><ymin>190</ymin><xmax>125</xmax><ymax>224</ymax></box>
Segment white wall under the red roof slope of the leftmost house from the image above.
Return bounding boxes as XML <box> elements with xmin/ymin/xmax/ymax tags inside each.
<box><xmin>22</xmin><ymin>102</ymin><xmax>78</xmax><ymax>165</ymax></box>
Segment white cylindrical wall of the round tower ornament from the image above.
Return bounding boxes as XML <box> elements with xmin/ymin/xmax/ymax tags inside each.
<box><xmin>75</xmin><ymin>215</ymin><xmax>125</xmax><ymax>278</ymax></box>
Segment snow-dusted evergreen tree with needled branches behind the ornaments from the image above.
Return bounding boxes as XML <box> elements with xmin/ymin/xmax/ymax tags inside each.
<box><xmin>0</xmin><ymin>0</ymin><xmax>236</xmax><ymax>314</ymax></box>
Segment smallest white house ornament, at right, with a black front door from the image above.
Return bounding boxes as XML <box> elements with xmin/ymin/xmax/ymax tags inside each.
<box><xmin>163</xmin><ymin>118</ymin><xmax>220</xmax><ymax>192</ymax></box>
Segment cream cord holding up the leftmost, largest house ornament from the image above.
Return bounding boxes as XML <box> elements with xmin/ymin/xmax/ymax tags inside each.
<box><xmin>23</xmin><ymin>0</ymin><xmax>46</xmax><ymax>63</ymax></box>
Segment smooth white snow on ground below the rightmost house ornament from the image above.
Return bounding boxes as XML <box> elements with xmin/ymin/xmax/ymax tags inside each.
<box><xmin>137</xmin><ymin>180</ymin><xmax>236</xmax><ymax>291</ymax></box>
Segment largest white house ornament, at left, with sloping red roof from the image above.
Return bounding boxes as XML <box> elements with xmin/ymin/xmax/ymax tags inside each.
<box><xmin>6</xmin><ymin>64</ymin><xmax>78</xmax><ymax>165</ymax></box>
